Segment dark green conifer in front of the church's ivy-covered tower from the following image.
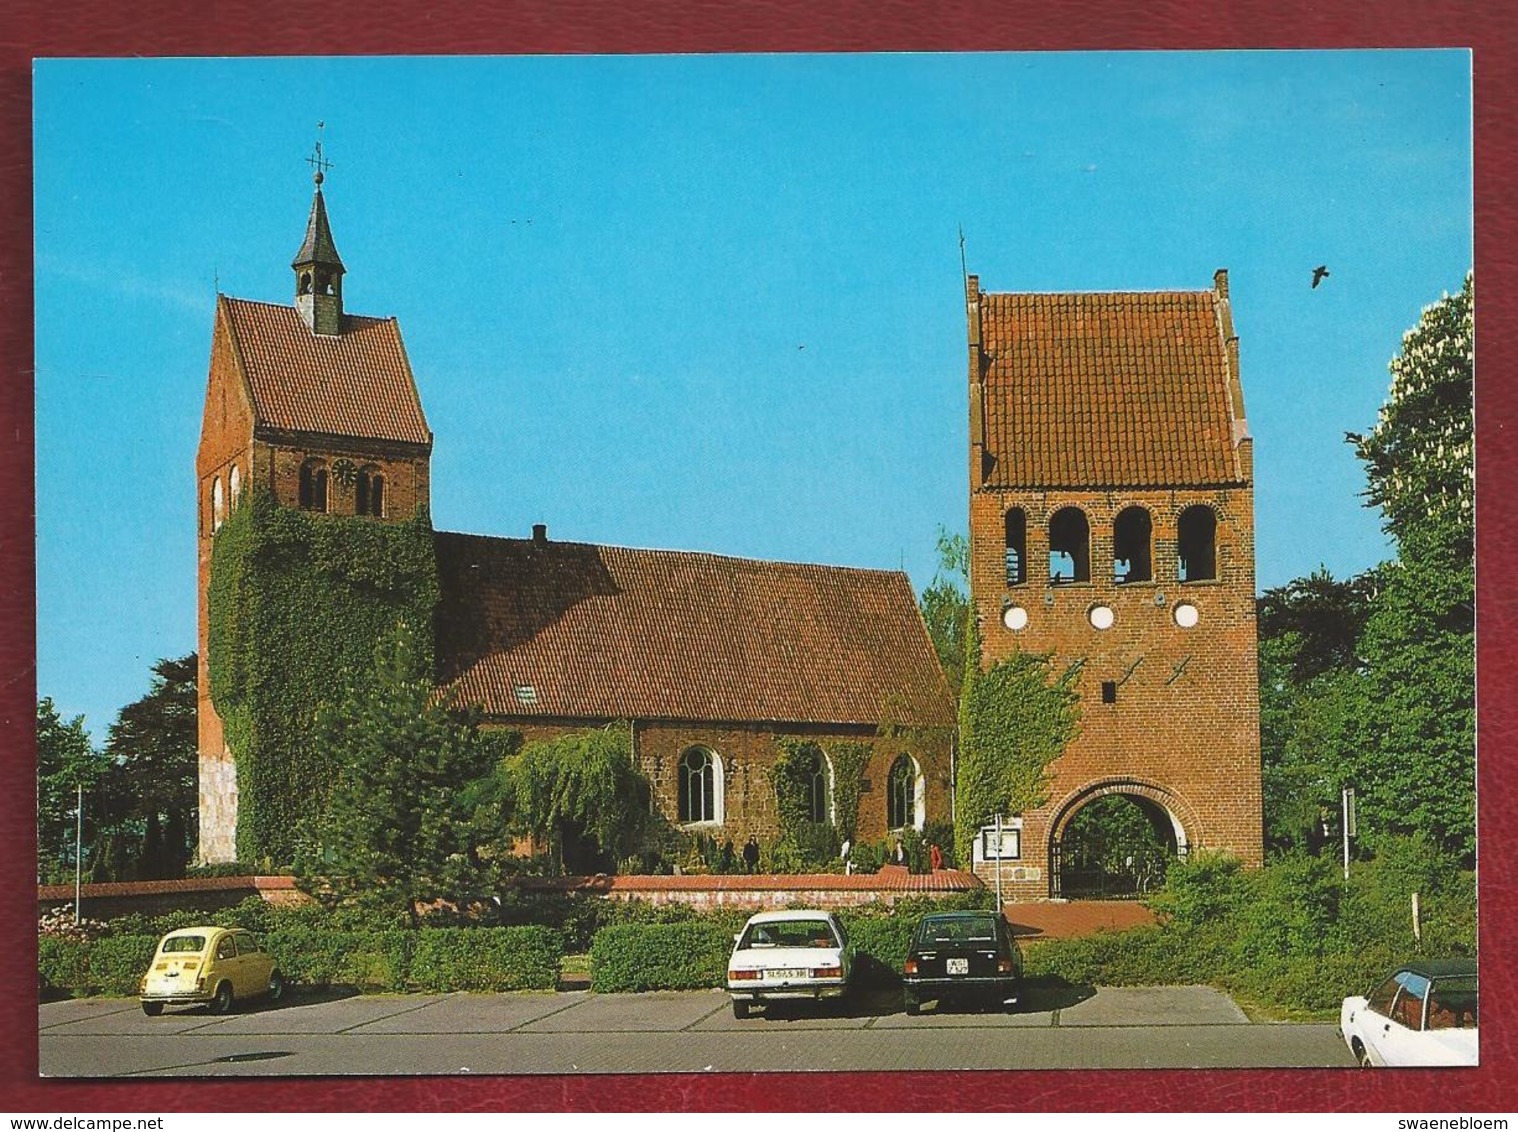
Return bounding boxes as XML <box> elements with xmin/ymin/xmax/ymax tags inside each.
<box><xmin>308</xmin><ymin>624</ymin><xmax>510</xmax><ymax>926</ymax></box>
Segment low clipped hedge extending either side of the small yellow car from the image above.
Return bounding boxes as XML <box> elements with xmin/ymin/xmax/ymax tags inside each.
<box><xmin>38</xmin><ymin>924</ymin><xmax>563</xmax><ymax>997</ymax></box>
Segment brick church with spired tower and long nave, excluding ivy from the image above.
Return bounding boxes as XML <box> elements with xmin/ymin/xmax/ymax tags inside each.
<box><xmin>186</xmin><ymin>173</ymin><xmax>955</xmax><ymax>862</ymax></box>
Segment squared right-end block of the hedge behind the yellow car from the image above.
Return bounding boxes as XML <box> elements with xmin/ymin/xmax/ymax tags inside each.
<box><xmin>408</xmin><ymin>926</ymin><xmax>563</xmax><ymax>992</ymax></box>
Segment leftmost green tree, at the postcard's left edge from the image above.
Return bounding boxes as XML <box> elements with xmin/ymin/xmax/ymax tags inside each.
<box><xmin>36</xmin><ymin>698</ymin><xmax>106</xmax><ymax>883</ymax></box>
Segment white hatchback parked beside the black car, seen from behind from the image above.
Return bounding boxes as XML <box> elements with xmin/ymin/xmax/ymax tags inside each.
<box><xmin>727</xmin><ymin>910</ymin><xmax>853</xmax><ymax>1018</ymax></box>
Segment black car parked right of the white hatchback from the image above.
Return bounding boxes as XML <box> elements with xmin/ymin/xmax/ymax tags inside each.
<box><xmin>903</xmin><ymin>912</ymin><xmax>1023</xmax><ymax>1014</ymax></box>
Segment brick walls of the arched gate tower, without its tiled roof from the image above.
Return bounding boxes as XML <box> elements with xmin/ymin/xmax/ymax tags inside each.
<box><xmin>970</xmin><ymin>268</ymin><xmax>1263</xmax><ymax>900</ymax></box>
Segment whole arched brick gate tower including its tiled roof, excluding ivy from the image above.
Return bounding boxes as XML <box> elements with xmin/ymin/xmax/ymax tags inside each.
<box><xmin>965</xmin><ymin>272</ymin><xmax>1263</xmax><ymax>898</ymax></box>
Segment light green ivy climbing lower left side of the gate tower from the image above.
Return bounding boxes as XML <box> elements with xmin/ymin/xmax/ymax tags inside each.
<box><xmin>955</xmin><ymin>618</ymin><xmax>1081</xmax><ymax>845</ymax></box>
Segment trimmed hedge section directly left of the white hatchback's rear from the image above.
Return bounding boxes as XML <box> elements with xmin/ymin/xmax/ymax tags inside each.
<box><xmin>591</xmin><ymin>917</ymin><xmax>736</xmax><ymax>994</ymax></box>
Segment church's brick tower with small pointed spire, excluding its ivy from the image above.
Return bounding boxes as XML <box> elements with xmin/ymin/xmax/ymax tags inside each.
<box><xmin>196</xmin><ymin>143</ymin><xmax>433</xmax><ymax>863</ymax></box>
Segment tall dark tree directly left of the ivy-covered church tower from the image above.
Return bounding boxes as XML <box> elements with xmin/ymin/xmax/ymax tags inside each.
<box><xmin>93</xmin><ymin>652</ymin><xmax>199</xmax><ymax>880</ymax></box>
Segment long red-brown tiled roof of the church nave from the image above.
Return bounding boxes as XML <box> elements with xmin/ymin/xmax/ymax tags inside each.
<box><xmin>437</xmin><ymin>533</ymin><xmax>955</xmax><ymax>727</ymax></box>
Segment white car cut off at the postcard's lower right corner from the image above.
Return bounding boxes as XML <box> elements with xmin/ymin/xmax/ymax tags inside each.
<box><xmin>1339</xmin><ymin>959</ymin><xmax>1479</xmax><ymax>1067</ymax></box>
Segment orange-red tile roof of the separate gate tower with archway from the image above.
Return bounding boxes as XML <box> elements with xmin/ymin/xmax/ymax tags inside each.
<box><xmin>979</xmin><ymin>291</ymin><xmax>1245</xmax><ymax>489</ymax></box>
